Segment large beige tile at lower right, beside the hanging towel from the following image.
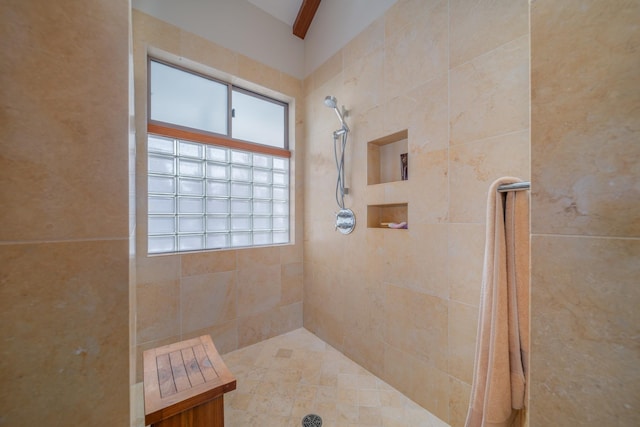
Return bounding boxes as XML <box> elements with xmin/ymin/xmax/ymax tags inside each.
<box><xmin>531</xmin><ymin>235</ymin><xmax>640</xmax><ymax>425</ymax></box>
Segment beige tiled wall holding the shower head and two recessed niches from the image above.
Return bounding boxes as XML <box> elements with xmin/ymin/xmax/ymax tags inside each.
<box><xmin>304</xmin><ymin>0</ymin><xmax>530</xmax><ymax>426</ymax></box>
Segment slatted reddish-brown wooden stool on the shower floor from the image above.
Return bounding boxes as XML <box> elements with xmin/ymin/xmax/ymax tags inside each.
<box><xmin>143</xmin><ymin>335</ymin><xmax>236</xmax><ymax>427</ymax></box>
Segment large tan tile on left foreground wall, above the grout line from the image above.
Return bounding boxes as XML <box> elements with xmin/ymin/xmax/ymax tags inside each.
<box><xmin>0</xmin><ymin>3</ymin><xmax>128</xmax><ymax>241</ymax></box>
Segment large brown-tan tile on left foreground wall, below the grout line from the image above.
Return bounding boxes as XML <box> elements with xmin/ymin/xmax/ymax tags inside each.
<box><xmin>0</xmin><ymin>241</ymin><xmax>129</xmax><ymax>425</ymax></box>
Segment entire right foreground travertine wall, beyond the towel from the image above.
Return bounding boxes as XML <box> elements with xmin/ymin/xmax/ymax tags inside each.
<box><xmin>530</xmin><ymin>0</ymin><xmax>640</xmax><ymax>426</ymax></box>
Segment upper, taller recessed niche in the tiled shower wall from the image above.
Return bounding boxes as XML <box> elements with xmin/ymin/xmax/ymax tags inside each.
<box><xmin>367</xmin><ymin>129</ymin><xmax>409</xmax><ymax>185</ymax></box>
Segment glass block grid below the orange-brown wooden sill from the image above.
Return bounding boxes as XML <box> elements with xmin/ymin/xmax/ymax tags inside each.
<box><xmin>148</xmin><ymin>135</ymin><xmax>289</xmax><ymax>254</ymax></box>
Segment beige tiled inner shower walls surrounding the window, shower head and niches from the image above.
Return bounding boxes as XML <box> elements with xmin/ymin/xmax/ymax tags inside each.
<box><xmin>133</xmin><ymin>1</ymin><xmax>530</xmax><ymax>425</ymax></box>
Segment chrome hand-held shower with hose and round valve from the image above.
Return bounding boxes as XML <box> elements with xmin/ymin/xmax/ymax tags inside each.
<box><xmin>324</xmin><ymin>96</ymin><xmax>356</xmax><ymax>234</ymax></box>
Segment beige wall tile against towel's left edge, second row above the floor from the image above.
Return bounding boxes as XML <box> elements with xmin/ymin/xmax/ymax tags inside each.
<box><xmin>449</xmin><ymin>301</ymin><xmax>478</xmax><ymax>384</ymax></box>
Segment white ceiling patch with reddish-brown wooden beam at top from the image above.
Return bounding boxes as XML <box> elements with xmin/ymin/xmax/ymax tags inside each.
<box><xmin>247</xmin><ymin>0</ymin><xmax>320</xmax><ymax>39</ymax></box>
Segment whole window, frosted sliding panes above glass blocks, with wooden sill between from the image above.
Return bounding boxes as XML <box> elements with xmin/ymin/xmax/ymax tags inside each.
<box><xmin>147</xmin><ymin>59</ymin><xmax>290</xmax><ymax>254</ymax></box>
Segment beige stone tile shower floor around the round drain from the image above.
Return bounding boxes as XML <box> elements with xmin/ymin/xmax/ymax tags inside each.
<box><xmin>132</xmin><ymin>329</ymin><xmax>448</xmax><ymax>427</ymax></box>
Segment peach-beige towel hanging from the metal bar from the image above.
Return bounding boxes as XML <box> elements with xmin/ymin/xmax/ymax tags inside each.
<box><xmin>465</xmin><ymin>177</ymin><xmax>529</xmax><ymax>427</ymax></box>
